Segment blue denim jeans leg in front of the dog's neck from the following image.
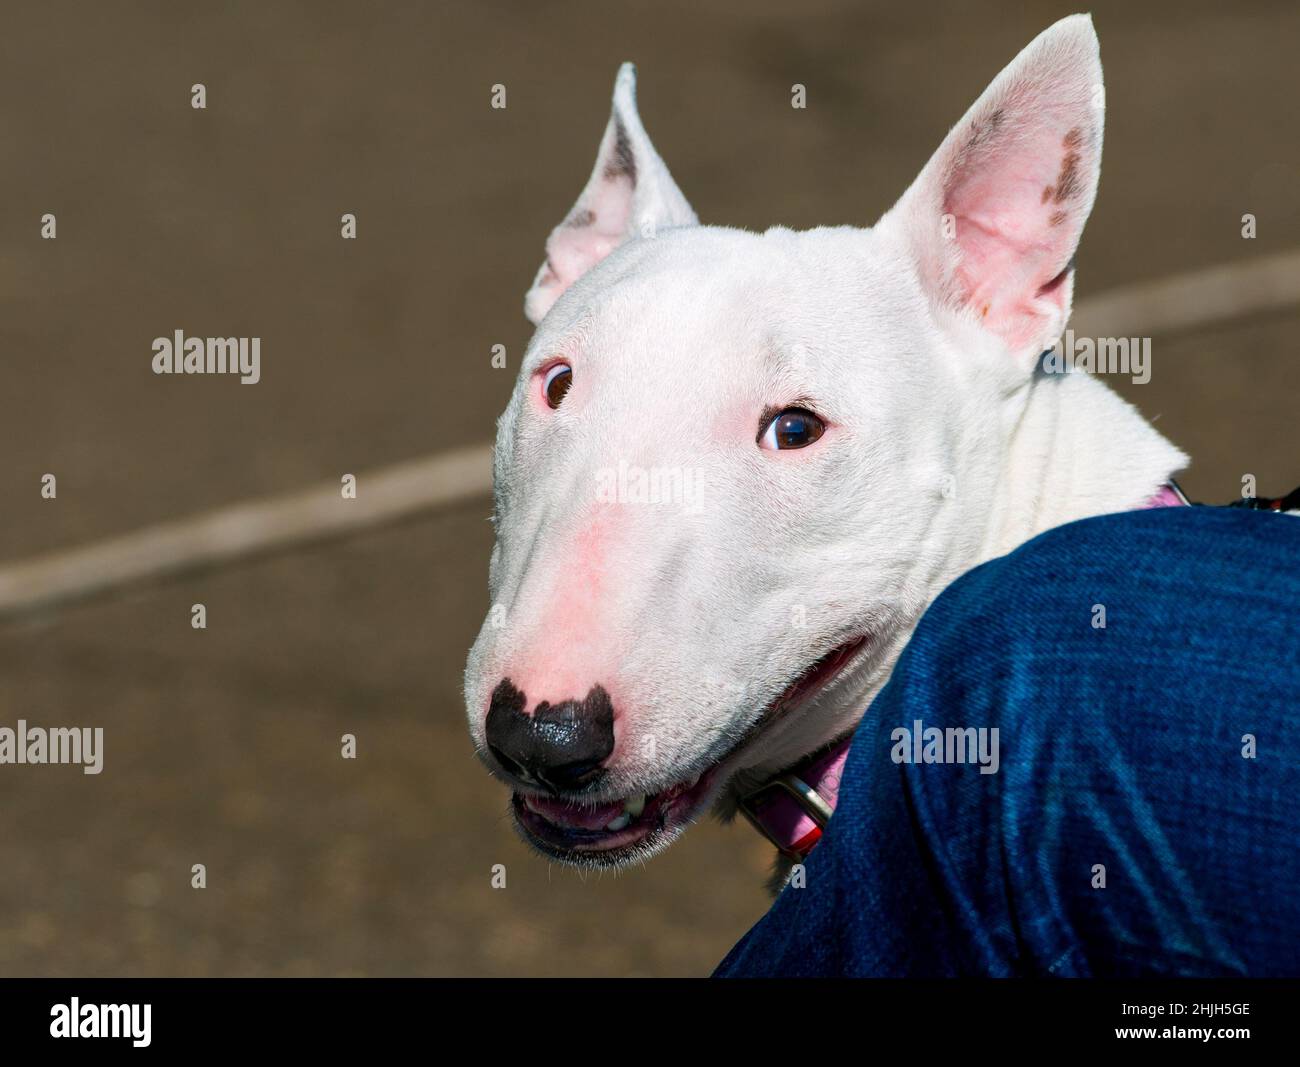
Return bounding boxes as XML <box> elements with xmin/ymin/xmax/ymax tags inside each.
<box><xmin>718</xmin><ymin>507</ymin><xmax>1300</xmax><ymax>976</ymax></box>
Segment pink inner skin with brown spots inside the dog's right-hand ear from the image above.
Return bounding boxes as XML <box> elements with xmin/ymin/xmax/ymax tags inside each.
<box><xmin>944</xmin><ymin>117</ymin><xmax>1091</xmax><ymax>348</ymax></box>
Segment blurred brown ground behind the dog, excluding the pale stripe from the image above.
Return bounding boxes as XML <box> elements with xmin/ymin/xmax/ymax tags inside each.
<box><xmin>0</xmin><ymin>0</ymin><xmax>1300</xmax><ymax>976</ymax></box>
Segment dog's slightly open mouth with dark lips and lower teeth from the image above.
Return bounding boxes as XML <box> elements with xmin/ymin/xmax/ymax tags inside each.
<box><xmin>511</xmin><ymin>637</ymin><xmax>867</xmax><ymax>867</ymax></box>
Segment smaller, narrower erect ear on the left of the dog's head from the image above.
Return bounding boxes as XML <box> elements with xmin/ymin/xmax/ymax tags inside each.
<box><xmin>524</xmin><ymin>62</ymin><xmax>699</xmax><ymax>324</ymax></box>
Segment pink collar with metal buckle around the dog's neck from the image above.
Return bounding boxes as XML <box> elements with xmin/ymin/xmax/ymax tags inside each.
<box><xmin>740</xmin><ymin>481</ymin><xmax>1188</xmax><ymax>863</ymax></box>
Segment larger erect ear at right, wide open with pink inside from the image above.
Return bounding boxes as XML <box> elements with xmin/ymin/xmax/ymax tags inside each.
<box><xmin>883</xmin><ymin>14</ymin><xmax>1105</xmax><ymax>355</ymax></box>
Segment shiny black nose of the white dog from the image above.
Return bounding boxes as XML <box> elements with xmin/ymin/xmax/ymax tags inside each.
<box><xmin>488</xmin><ymin>678</ymin><xmax>614</xmax><ymax>793</ymax></box>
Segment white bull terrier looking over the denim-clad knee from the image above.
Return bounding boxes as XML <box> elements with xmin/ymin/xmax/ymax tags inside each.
<box><xmin>465</xmin><ymin>16</ymin><xmax>1186</xmax><ymax>867</ymax></box>
